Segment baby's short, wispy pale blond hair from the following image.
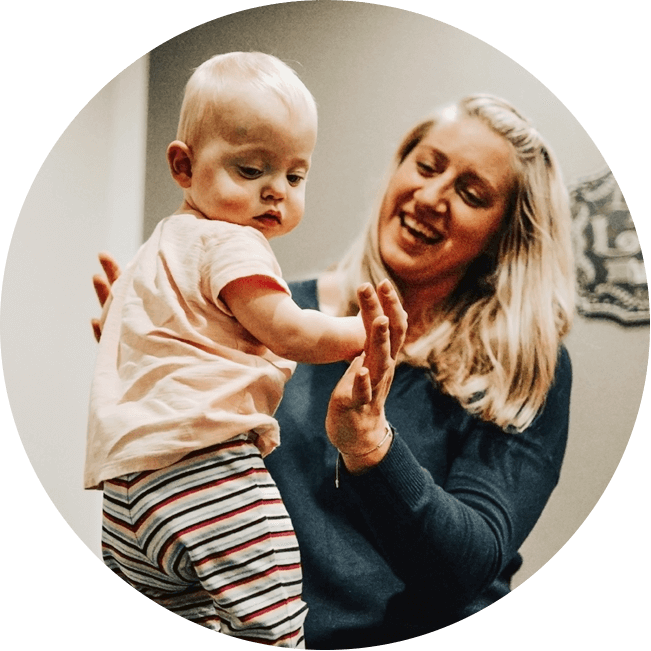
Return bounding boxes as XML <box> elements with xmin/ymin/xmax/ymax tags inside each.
<box><xmin>176</xmin><ymin>52</ymin><xmax>316</xmax><ymax>147</ymax></box>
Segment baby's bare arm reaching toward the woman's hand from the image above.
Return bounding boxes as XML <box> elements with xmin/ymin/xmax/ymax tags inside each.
<box><xmin>219</xmin><ymin>276</ymin><xmax>366</xmax><ymax>364</ymax></box>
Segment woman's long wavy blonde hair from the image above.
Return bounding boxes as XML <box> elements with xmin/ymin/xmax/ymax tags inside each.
<box><xmin>337</xmin><ymin>95</ymin><xmax>575</xmax><ymax>432</ymax></box>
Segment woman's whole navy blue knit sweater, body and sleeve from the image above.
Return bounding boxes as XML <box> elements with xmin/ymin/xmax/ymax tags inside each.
<box><xmin>266</xmin><ymin>281</ymin><xmax>572</xmax><ymax>649</ymax></box>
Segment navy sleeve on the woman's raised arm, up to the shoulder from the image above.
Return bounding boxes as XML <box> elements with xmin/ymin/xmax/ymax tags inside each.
<box><xmin>341</xmin><ymin>349</ymin><xmax>571</xmax><ymax>608</ymax></box>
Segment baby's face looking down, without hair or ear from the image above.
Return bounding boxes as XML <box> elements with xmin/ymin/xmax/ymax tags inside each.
<box><xmin>185</xmin><ymin>86</ymin><xmax>317</xmax><ymax>239</ymax></box>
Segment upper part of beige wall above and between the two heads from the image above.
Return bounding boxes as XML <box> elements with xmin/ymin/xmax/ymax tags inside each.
<box><xmin>145</xmin><ymin>1</ymin><xmax>605</xmax><ymax>278</ymax></box>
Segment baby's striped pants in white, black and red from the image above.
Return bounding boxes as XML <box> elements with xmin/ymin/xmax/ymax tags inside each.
<box><xmin>102</xmin><ymin>435</ymin><xmax>307</xmax><ymax>649</ymax></box>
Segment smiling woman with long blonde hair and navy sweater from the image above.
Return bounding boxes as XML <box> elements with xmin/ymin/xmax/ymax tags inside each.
<box><xmin>96</xmin><ymin>96</ymin><xmax>574</xmax><ymax>649</ymax></box>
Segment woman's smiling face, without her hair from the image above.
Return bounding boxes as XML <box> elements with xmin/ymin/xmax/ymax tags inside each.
<box><xmin>378</xmin><ymin>117</ymin><xmax>515</xmax><ymax>293</ymax></box>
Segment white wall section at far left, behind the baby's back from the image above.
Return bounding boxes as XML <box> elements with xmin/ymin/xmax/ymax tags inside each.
<box><xmin>2</xmin><ymin>57</ymin><xmax>148</xmax><ymax>554</ymax></box>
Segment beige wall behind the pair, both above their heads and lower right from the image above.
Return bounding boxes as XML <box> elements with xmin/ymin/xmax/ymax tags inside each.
<box><xmin>145</xmin><ymin>2</ymin><xmax>649</xmax><ymax>584</ymax></box>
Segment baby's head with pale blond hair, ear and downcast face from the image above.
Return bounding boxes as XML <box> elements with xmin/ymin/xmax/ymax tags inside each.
<box><xmin>167</xmin><ymin>52</ymin><xmax>317</xmax><ymax>239</ymax></box>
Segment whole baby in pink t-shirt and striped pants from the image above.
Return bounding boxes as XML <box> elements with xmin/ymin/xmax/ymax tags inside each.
<box><xmin>84</xmin><ymin>52</ymin><xmax>365</xmax><ymax>648</ymax></box>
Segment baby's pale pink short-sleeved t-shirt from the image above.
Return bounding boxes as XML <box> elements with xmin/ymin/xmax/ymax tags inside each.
<box><xmin>84</xmin><ymin>214</ymin><xmax>296</xmax><ymax>488</ymax></box>
